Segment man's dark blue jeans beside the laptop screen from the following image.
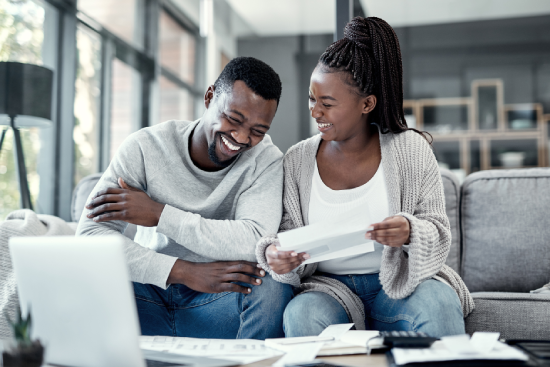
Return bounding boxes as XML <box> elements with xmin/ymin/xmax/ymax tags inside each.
<box><xmin>134</xmin><ymin>274</ymin><xmax>293</xmax><ymax>339</ymax></box>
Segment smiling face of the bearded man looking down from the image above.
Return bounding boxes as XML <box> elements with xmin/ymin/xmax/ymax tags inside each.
<box><xmin>203</xmin><ymin>80</ymin><xmax>277</xmax><ymax>167</ymax></box>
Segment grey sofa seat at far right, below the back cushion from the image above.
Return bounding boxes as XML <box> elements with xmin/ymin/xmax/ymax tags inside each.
<box><xmin>465</xmin><ymin>292</ymin><xmax>550</xmax><ymax>340</ymax></box>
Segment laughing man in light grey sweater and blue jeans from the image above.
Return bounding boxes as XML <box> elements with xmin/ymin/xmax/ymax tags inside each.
<box><xmin>77</xmin><ymin>57</ymin><xmax>292</xmax><ymax>339</ymax></box>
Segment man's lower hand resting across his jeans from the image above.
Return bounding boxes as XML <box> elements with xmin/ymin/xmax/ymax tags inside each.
<box><xmin>167</xmin><ymin>259</ymin><xmax>265</xmax><ymax>294</ymax></box>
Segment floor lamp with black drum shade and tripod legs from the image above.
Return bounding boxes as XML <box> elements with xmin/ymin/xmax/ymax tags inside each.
<box><xmin>0</xmin><ymin>62</ymin><xmax>53</xmax><ymax>209</ymax></box>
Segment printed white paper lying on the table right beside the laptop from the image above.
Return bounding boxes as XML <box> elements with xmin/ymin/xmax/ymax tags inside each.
<box><xmin>140</xmin><ymin>336</ymin><xmax>282</xmax><ymax>364</ymax></box>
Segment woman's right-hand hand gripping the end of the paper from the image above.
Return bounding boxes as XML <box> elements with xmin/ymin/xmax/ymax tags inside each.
<box><xmin>365</xmin><ymin>215</ymin><xmax>411</xmax><ymax>247</ymax></box>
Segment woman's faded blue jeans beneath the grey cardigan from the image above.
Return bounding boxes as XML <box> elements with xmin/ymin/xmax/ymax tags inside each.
<box><xmin>284</xmin><ymin>273</ymin><xmax>465</xmax><ymax>338</ymax></box>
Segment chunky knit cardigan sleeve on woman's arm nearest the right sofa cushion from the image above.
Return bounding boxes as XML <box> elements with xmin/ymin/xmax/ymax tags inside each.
<box><xmin>380</xmin><ymin>142</ymin><xmax>451</xmax><ymax>299</ymax></box>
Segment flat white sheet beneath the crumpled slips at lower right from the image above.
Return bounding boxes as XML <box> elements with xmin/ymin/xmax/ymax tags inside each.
<box><xmin>392</xmin><ymin>341</ymin><xmax>529</xmax><ymax>365</ymax></box>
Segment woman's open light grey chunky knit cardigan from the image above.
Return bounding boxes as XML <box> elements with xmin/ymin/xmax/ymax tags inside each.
<box><xmin>256</xmin><ymin>130</ymin><xmax>474</xmax><ymax>329</ymax></box>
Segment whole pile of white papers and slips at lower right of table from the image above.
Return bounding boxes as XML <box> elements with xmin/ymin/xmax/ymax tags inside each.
<box><xmin>392</xmin><ymin>332</ymin><xmax>529</xmax><ymax>365</ymax></box>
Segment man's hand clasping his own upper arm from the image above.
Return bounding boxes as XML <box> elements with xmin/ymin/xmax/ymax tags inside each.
<box><xmin>86</xmin><ymin>178</ymin><xmax>164</xmax><ymax>227</ymax></box>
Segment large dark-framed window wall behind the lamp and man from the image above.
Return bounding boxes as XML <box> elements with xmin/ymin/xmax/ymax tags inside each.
<box><xmin>0</xmin><ymin>0</ymin><xmax>202</xmax><ymax>220</ymax></box>
